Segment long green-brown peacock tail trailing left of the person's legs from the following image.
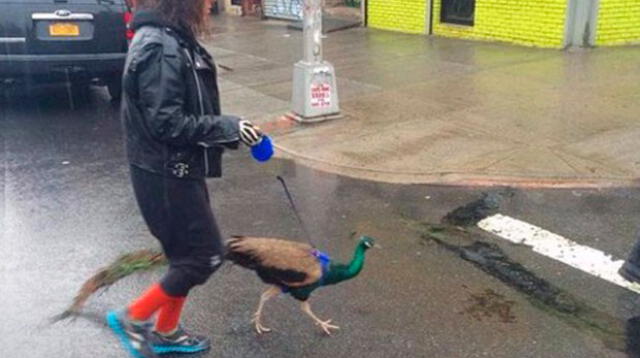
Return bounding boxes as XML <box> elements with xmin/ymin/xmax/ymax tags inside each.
<box><xmin>52</xmin><ymin>250</ymin><xmax>167</xmax><ymax>322</ymax></box>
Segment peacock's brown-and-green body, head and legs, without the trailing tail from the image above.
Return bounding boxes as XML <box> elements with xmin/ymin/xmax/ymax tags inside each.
<box><xmin>227</xmin><ymin>236</ymin><xmax>375</xmax><ymax>335</ymax></box>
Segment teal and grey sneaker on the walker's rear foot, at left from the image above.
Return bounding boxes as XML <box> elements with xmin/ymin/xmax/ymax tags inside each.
<box><xmin>107</xmin><ymin>311</ymin><xmax>158</xmax><ymax>358</ymax></box>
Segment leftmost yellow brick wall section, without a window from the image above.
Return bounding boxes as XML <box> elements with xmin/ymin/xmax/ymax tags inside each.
<box><xmin>367</xmin><ymin>0</ymin><xmax>426</xmax><ymax>33</ymax></box>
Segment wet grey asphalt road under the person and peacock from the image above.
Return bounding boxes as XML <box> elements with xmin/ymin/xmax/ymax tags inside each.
<box><xmin>0</xmin><ymin>86</ymin><xmax>640</xmax><ymax>358</ymax></box>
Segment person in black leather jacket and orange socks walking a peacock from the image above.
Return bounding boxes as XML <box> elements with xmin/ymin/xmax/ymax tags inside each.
<box><xmin>107</xmin><ymin>0</ymin><xmax>262</xmax><ymax>358</ymax></box>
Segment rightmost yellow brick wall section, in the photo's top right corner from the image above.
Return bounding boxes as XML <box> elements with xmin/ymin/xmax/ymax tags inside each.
<box><xmin>596</xmin><ymin>0</ymin><xmax>640</xmax><ymax>45</ymax></box>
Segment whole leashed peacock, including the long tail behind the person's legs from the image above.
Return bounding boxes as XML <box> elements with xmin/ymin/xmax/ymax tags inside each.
<box><xmin>53</xmin><ymin>236</ymin><xmax>379</xmax><ymax>335</ymax></box>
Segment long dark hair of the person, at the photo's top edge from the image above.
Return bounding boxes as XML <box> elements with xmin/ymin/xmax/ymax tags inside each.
<box><xmin>136</xmin><ymin>0</ymin><xmax>207</xmax><ymax>35</ymax></box>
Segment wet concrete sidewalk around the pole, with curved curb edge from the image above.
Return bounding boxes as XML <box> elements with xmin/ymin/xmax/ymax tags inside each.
<box><xmin>207</xmin><ymin>16</ymin><xmax>640</xmax><ymax>187</ymax></box>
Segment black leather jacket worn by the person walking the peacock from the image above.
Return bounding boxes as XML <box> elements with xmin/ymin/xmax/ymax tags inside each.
<box><xmin>122</xmin><ymin>11</ymin><xmax>240</xmax><ymax>178</ymax></box>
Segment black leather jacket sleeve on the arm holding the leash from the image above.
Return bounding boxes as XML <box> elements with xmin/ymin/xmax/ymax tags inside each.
<box><xmin>137</xmin><ymin>44</ymin><xmax>240</xmax><ymax>148</ymax></box>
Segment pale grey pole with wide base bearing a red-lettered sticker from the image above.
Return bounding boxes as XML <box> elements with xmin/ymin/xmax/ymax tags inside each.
<box><xmin>291</xmin><ymin>0</ymin><xmax>340</xmax><ymax>122</ymax></box>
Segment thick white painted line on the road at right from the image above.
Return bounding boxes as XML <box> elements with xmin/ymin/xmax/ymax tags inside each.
<box><xmin>478</xmin><ymin>214</ymin><xmax>640</xmax><ymax>293</ymax></box>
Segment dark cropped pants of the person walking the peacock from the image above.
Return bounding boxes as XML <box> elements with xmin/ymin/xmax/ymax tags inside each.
<box><xmin>131</xmin><ymin>165</ymin><xmax>224</xmax><ymax>297</ymax></box>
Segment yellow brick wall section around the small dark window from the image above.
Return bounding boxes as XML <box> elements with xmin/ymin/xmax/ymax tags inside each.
<box><xmin>433</xmin><ymin>0</ymin><xmax>568</xmax><ymax>48</ymax></box>
